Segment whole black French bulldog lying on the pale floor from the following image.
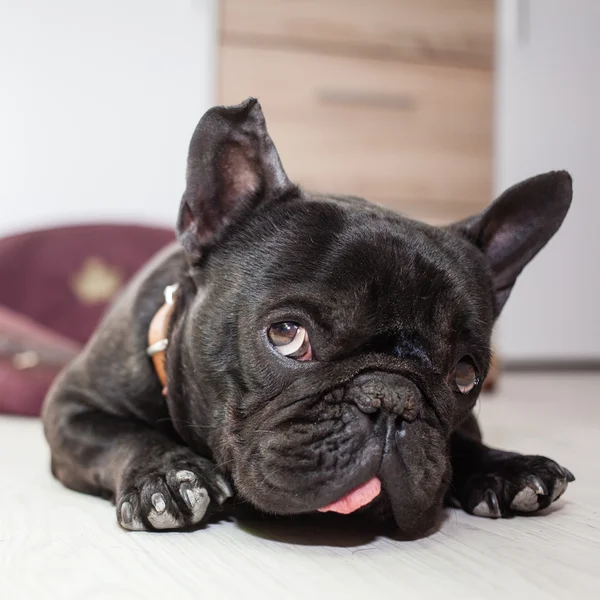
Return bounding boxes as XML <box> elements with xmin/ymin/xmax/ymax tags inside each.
<box><xmin>39</xmin><ymin>99</ymin><xmax>573</xmax><ymax>537</ymax></box>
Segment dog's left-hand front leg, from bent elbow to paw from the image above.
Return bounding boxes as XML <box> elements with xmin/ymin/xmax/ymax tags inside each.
<box><xmin>44</xmin><ymin>390</ymin><xmax>232</xmax><ymax>530</ymax></box>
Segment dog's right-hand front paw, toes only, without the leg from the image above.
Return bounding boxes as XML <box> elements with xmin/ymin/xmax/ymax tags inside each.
<box><xmin>457</xmin><ymin>455</ymin><xmax>575</xmax><ymax>519</ymax></box>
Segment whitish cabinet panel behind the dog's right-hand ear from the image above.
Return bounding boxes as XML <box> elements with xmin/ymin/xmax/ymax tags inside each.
<box><xmin>495</xmin><ymin>0</ymin><xmax>600</xmax><ymax>360</ymax></box>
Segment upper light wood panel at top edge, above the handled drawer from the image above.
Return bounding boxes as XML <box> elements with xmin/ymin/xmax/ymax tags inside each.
<box><xmin>221</xmin><ymin>0</ymin><xmax>494</xmax><ymax>69</ymax></box>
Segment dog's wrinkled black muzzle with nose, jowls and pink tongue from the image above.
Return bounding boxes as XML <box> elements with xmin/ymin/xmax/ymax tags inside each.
<box><xmin>228</xmin><ymin>371</ymin><xmax>445</xmax><ymax>522</ymax></box>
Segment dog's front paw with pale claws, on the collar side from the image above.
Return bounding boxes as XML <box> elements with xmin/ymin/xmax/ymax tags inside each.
<box><xmin>116</xmin><ymin>453</ymin><xmax>232</xmax><ymax>531</ymax></box>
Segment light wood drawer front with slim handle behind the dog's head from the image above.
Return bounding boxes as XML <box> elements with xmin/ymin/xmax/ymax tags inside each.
<box><xmin>220</xmin><ymin>44</ymin><xmax>492</xmax><ymax>222</ymax></box>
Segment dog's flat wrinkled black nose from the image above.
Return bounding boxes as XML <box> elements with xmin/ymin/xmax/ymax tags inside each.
<box><xmin>345</xmin><ymin>373</ymin><xmax>421</xmax><ymax>416</ymax></box>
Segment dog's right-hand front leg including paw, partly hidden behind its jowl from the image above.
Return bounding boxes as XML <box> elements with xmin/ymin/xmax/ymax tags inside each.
<box><xmin>448</xmin><ymin>415</ymin><xmax>575</xmax><ymax>518</ymax></box>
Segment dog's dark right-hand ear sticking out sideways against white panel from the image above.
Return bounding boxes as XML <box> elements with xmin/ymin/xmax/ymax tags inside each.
<box><xmin>451</xmin><ymin>171</ymin><xmax>572</xmax><ymax>317</ymax></box>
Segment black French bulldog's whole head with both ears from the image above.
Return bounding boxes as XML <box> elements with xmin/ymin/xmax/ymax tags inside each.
<box><xmin>169</xmin><ymin>99</ymin><xmax>571</xmax><ymax>535</ymax></box>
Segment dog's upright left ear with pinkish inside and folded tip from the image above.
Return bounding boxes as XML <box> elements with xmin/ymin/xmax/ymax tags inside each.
<box><xmin>177</xmin><ymin>98</ymin><xmax>297</xmax><ymax>263</ymax></box>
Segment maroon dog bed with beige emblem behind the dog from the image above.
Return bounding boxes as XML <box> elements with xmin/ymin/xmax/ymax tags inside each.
<box><xmin>0</xmin><ymin>225</ymin><xmax>173</xmax><ymax>416</ymax></box>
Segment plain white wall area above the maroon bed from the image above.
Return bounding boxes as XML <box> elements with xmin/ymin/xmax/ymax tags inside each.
<box><xmin>0</xmin><ymin>0</ymin><xmax>216</xmax><ymax>235</ymax></box>
